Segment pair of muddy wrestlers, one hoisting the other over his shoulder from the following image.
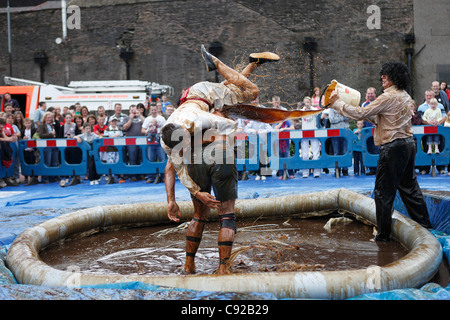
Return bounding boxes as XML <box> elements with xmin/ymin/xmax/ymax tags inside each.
<box><xmin>161</xmin><ymin>46</ymin><xmax>279</xmax><ymax>274</ymax></box>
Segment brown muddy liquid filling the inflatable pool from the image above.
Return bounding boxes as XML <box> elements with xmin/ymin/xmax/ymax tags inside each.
<box><xmin>40</xmin><ymin>217</ymin><xmax>408</xmax><ymax>275</ymax></box>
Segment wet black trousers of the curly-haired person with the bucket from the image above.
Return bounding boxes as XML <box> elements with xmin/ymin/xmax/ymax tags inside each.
<box><xmin>374</xmin><ymin>137</ymin><xmax>431</xmax><ymax>241</ymax></box>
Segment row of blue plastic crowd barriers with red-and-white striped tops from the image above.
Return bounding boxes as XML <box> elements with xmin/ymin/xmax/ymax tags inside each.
<box><xmin>7</xmin><ymin>126</ymin><xmax>450</xmax><ymax>177</ymax></box>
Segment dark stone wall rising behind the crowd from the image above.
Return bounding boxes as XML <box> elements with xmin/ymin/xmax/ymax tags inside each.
<box><xmin>0</xmin><ymin>0</ymin><xmax>414</xmax><ymax>106</ymax></box>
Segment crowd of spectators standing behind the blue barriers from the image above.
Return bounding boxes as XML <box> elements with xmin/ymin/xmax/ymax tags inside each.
<box><xmin>0</xmin><ymin>81</ymin><xmax>450</xmax><ymax>188</ymax></box>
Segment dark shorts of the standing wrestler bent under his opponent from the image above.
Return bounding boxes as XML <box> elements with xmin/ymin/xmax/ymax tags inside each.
<box><xmin>188</xmin><ymin>141</ymin><xmax>238</xmax><ymax>202</ymax></box>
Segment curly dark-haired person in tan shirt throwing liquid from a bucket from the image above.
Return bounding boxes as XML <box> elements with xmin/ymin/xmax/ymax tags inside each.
<box><xmin>329</xmin><ymin>61</ymin><xmax>431</xmax><ymax>241</ymax></box>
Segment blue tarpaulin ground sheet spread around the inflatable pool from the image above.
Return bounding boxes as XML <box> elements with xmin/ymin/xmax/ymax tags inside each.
<box><xmin>0</xmin><ymin>174</ymin><xmax>450</xmax><ymax>300</ymax></box>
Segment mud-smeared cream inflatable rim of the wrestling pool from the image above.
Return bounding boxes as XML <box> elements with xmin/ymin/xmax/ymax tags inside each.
<box><xmin>6</xmin><ymin>189</ymin><xmax>442</xmax><ymax>299</ymax></box>
